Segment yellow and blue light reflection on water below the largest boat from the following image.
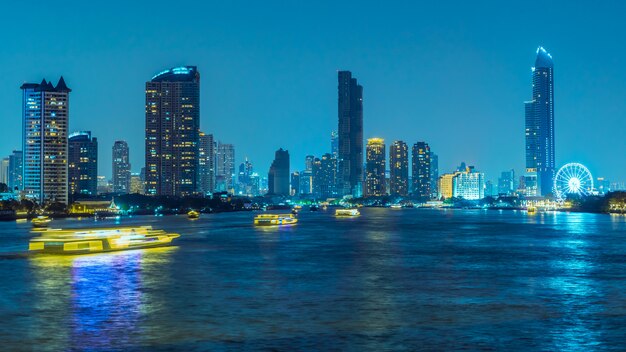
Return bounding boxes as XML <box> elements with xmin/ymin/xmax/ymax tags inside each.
<box><xmin>30</xmin><ymin>247</ymin><xmax>176</xmax><ymax>350</ymax></box>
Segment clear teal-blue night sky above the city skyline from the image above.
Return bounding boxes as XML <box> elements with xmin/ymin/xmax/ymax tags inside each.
<box><xmin>0</xmin><ymin>1</ymin><xmax>626</xmax><ymax>181</ymax></box>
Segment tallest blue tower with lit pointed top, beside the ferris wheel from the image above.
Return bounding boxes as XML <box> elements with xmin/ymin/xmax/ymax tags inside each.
<box><xmin>524</xmin><ymin>47</ymin><xmax>555</xmax><ymax>196</ymax></box>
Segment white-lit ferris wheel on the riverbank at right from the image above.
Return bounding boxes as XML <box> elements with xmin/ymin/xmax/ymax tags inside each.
<box><xmin>554</xmin><ymin>163</ymin><xmax>593</xmax><ymax>200</ymax></box>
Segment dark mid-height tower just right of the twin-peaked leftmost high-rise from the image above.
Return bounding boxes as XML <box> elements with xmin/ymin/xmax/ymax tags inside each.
<box><xmin>67</xmin><ymin>131</ymin><xmax>98</xmax><ymax>196</ymax></box>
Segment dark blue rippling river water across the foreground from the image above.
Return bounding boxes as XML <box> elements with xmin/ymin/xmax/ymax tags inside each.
<box><xmin>0</xmin><ymin>209</ymin><xmax>626</xmax><ymax>351</ymax></box>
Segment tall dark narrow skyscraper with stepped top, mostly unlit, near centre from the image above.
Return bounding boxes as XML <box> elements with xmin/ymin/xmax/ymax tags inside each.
<box><xmin>337</xmin><ymin>71</ymin><xmax>363</xmax><ymax>197</ymax></box>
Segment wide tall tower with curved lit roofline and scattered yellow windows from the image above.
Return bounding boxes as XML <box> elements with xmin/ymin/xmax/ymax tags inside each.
<box><xmin>146</xmin><ymin>66</ymin><xmax>200</xmax><ymax>196</ymax></box>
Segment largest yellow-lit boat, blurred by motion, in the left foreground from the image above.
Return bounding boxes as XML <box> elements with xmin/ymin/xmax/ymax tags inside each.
<box><xmin>28</xmin><ymin>226</ymin><xmax>180</xmax><ymax>254</ymax></box>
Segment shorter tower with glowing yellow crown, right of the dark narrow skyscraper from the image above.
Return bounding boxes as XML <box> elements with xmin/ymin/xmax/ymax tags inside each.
<box><xmin>365</xmin><ymin>138</ymin><xmax>386</xmax><ymax>197</ymax></box>
